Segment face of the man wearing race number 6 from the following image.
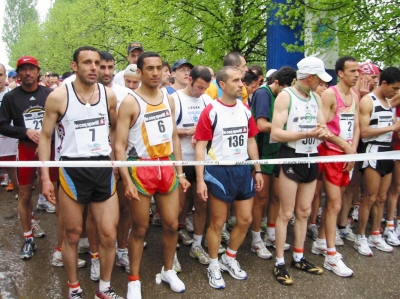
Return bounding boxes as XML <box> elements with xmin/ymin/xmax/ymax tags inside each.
<box><xmin>136</xmin><ymin>57</ymin><xmax>162</xmax><ymax>88</ymax></box>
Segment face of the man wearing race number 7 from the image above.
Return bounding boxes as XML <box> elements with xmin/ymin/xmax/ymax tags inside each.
<box><xmin>71</xmin><ymin>51</ymin><xmax>100</xmax><ymax>85</ymax></box>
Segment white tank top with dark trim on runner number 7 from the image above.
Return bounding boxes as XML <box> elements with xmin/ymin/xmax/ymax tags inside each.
<box><xmin>55</xmin><ymin>83</ymin><xmax>111</xmax><ymax>158</ymax></box>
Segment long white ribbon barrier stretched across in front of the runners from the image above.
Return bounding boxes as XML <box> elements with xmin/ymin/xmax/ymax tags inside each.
<box><xmin>0</xmin><ymin>151</ymin><xmax>400</xmax><ymax>167</ymax></box>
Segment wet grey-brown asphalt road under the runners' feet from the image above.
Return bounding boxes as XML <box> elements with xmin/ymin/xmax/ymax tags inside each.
<box><xmin>0</xmin><ymin>188</ymin><xmax>400</xmax><ymax>299</ymax></box>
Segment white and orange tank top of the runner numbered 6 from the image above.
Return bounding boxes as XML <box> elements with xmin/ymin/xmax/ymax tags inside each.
<box><xmin>127</xmin><ymin>90</ymin><xmax>175</xmax><ymax>159</ymax></box>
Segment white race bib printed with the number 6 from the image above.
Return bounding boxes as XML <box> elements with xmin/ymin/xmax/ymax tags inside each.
<box><xmin>144</xmin><ymin>108</ymin><xmax>173</xmax><ymax>146</ymax></box>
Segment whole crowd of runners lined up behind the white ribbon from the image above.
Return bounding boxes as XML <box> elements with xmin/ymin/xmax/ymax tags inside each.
<box><xmin>0</xmin><ymin>42</ymin><xmax>400</xmax><ymax>299</ymax></box>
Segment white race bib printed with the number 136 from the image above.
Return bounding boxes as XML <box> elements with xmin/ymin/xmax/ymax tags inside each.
<box><xmin>222</xmin><ymin>126</ymin><xmax>248</xmax><ymax>160</ymax></box>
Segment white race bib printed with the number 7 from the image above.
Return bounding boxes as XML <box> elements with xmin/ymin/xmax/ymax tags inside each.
<box><xmin>74</xmin><ymin>116</ymin><xmax>110</xmax><ymax>156</ymax></box>
